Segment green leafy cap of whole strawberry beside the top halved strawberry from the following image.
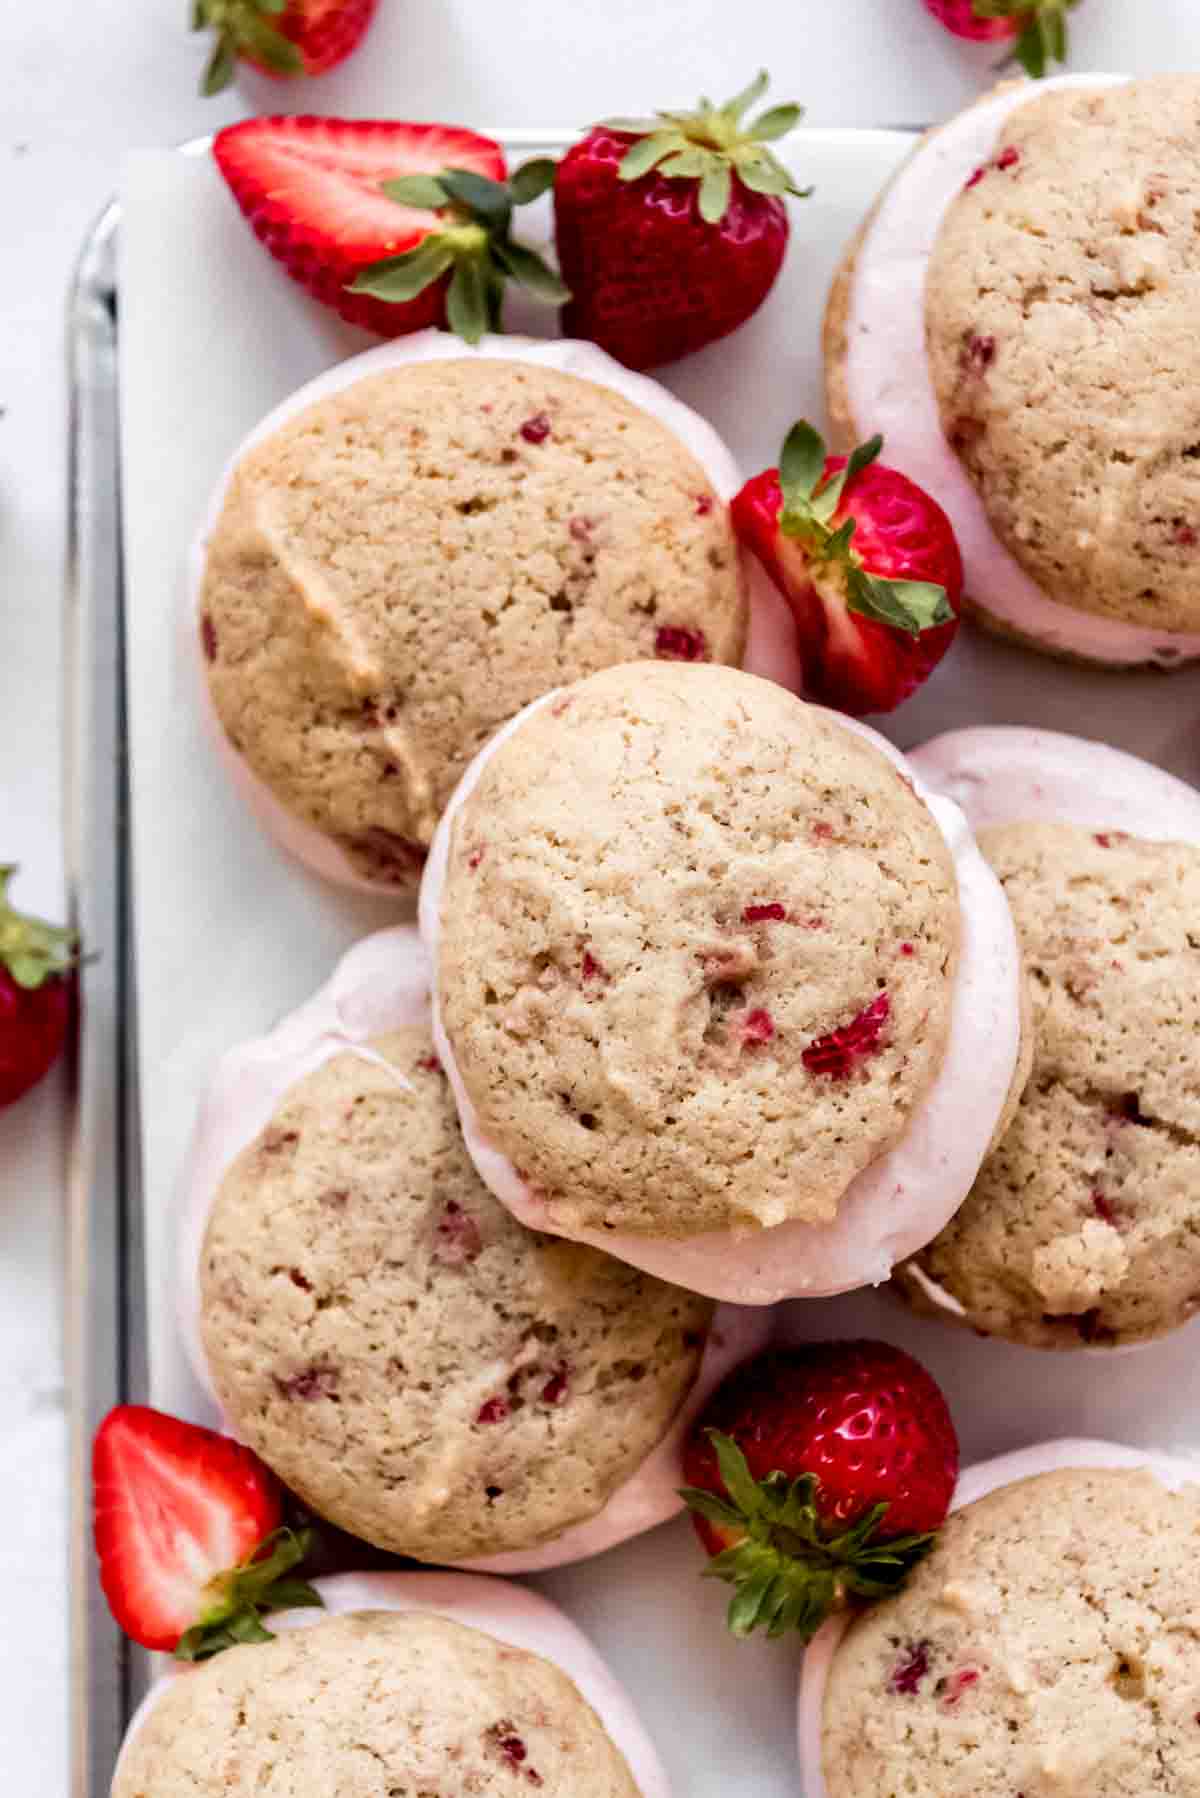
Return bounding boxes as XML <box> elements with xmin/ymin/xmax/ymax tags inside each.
<box><xmin>606</xmin><ymin>70</ymin><xmax>811</xmax><ymax>225</ymax></box>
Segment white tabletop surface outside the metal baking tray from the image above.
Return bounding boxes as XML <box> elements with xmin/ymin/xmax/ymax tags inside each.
<box><xmin>0</xmin><ymin>0</ymin><xmax>1200</xmax><ymax>1798</ymax></box>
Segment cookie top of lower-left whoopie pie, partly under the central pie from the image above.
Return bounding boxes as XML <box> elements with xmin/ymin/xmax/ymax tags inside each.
<box><xmin>200</xmin><ymin>1027</ymin><xmax>712</xmax><ymax>1561</ymax></box>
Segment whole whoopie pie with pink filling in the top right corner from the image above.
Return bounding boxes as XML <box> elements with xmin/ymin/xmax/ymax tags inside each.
<box><xmin>826</xmin><ymin>76</ymin><xmax>1200</xmax><ymax>667</ymax></box>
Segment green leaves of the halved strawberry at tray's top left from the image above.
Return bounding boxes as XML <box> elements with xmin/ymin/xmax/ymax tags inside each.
<box><xmin>347</xmin><ymin>156</ymin><xmax>570</xmax><ymax>343</ymax></box>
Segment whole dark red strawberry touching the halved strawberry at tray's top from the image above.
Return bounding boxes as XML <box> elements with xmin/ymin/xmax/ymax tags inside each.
<box><xmin>554</xmin><ymin>74</ymin><xmax>811</xmax><ymax>369</ymax></box>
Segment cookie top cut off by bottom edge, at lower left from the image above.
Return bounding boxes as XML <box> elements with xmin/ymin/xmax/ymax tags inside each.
<box><xmin>113</xmin><ymin>1611</ymin><xmax>637</xmax><ymax>1798</ymax></box>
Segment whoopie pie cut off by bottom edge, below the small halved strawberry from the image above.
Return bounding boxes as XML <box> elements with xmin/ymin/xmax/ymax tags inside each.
<box><xmin>112</xmin><ymin>1573</ymin><xmax>669</xmax><ymax>1798</ymax></box>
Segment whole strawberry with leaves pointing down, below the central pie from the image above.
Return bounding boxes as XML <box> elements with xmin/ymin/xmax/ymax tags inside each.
<box><xmin>682</xmin><ymin>1341</ymin><xmax>959</xmax><ymax>1642</ymax></box>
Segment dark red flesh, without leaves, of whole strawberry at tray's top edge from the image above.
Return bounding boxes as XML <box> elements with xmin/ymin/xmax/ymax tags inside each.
<box><xmin>554</xmin><ymin>126</ymin><xmax>788</xmax><ymax>369</ymax></box>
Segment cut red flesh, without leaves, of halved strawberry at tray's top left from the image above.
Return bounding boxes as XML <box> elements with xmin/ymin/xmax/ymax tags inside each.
<box><xmin>212</xmin><ymin>115</ymin><xmax>507</xmax><ymax>336</ymax></box>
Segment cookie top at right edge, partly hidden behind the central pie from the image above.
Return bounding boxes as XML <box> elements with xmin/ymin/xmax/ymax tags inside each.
<box><xmin>916</xmin><ymin>823</ymin><xmax>1200</xmax><ymax>1349</ymax></box>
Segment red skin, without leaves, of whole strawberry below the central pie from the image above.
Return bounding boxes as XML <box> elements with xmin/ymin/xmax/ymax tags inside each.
<box><xmin>684</xmin><ymin>1341</ymin><xmax>959</xmax><ymax>1555</ymax></box>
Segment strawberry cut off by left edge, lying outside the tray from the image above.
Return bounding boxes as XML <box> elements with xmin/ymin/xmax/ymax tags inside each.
<box><xmin>0</xmin><ymin>867</ymin><xmax>77</xmax><ymax>1108</ymax></box>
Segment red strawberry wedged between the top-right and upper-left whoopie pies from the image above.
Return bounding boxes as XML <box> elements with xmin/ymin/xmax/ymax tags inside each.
<box><xmin>730</xmin><ymin>423</ymin><xmax>963</xmax><ymax>717</ymax></box>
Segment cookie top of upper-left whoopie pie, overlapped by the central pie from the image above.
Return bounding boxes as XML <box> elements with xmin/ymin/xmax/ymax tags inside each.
<box><xmin>198</xmin><ymin>358</ymin><xmax>748</xmax><ymax>886</ymax></box>
